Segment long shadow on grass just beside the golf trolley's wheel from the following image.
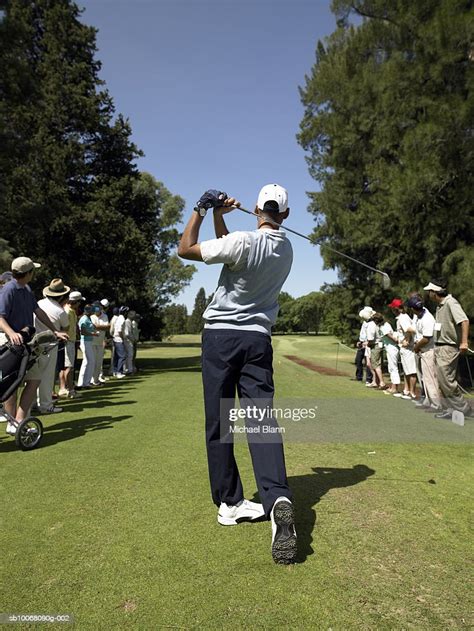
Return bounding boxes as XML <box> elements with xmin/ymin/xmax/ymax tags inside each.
<box><xmin>0</xmin><ymin>415</ymin><xmax>133</xmax><ymax>453</ymax></box>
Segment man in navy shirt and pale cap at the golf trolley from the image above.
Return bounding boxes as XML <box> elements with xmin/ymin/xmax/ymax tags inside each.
<box><xmin>0</xmin><ymin>256</ymin><xmax>68</xmax><ymax>435</ymax></box>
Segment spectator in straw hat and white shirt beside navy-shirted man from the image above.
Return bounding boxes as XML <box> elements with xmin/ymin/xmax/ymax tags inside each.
<box><xmin>34</xmin><ymin>278</ymin><xmax>70</xmax><ymax>414</ymax></box>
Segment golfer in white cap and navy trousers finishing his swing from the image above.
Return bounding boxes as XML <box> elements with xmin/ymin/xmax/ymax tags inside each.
<box><xmin>178</xmin><ymin>184</ymin><xmax>296</xmax><ymax>564</ymax></box>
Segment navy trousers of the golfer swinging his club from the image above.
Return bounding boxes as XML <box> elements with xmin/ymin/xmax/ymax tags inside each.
<box><xmin>202</xmin><ymin>329</ymin><xmax>291</xmax><ymax>517</ymax></box>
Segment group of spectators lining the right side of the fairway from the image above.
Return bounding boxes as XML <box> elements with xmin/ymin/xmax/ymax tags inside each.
<box><xmin>355</xmin><ymin>279</ymin><xmax>473</xmax><ymax>418</ymax></box>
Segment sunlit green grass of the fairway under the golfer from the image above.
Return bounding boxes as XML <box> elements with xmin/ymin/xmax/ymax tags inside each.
<box><xmin>0</xmin><ymin>336</ymin><xmax>473</xmax><ymax>630</ymax></box>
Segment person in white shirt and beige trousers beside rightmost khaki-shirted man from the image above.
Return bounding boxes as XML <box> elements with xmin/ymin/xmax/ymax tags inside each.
<box><xmin>407</xmin><ymin>295</ymin><xmax>442</xmax><ymax>412</ymax></box>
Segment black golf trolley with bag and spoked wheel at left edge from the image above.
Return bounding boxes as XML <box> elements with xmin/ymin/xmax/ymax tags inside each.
<box><xmin>0</xmin><ymin>327</ymin><xmax>58</xmax><ymax>451</ymax></box>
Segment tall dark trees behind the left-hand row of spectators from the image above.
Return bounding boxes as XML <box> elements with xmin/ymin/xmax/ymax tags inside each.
<box><xmin>0</xmin><ymin>0</ymin><xmax>195</xmax><ymax>336</ymax></box>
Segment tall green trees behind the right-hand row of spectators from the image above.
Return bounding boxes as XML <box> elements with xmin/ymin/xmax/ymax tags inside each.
<box><xmin>298</xmin><ymin>0</ymin><xmax>474</xmax><ymax>338</ymax></box>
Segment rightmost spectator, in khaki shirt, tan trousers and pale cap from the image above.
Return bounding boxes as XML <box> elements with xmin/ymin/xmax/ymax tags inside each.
<box><xmin>424</xmin><ymin>279</ymin><xmax>472</xmax><ymax>418</ymax></box>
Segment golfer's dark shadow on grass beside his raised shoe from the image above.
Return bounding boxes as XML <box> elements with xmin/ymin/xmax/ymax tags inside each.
<box><xmin>288</xmin><ymin>464</ymin><xmax>375</xmax><ymax>563</ymax></box>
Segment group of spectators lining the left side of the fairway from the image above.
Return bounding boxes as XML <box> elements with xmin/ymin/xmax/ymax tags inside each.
<box><xmin>0</xmin><ymin>257</ymin><xmax>139</xmax><ymax>434</ymax></box>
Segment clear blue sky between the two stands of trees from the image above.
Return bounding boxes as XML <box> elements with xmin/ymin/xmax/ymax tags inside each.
<box><xmin>78</xmin><ymin>0</ymin><xmax>336</xmax><ymax>309</ymax></box>
